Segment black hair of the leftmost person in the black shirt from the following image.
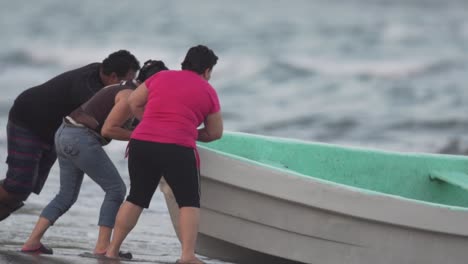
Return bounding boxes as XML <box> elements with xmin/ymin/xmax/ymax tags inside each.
<box><xmin>102</xmin><ymin>50</ymin><xmax>140</xmax><ymax>78</ymax></box>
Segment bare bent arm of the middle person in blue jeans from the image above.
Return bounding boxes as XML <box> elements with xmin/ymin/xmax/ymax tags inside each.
<box><xmin>101</xmin><ymin>89</ymin><xmax>133</xmax><ymax>140</ymax></box>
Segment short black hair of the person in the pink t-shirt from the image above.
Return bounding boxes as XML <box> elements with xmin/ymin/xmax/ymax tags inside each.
<box><xmin>182</xmin><ymin>45</ymin><xmax>218</xmax><ymax>74</ymax></box>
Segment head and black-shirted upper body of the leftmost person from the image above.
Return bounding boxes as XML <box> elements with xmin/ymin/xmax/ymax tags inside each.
<box><xmin>9</xmin><ymin>50</ymin><xmax>140</xmax><ymax>144</ymax></box>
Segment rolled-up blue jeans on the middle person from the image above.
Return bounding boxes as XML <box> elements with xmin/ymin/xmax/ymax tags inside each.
<box><xmin>41</xmin><ymin>123</ymin><xmax>126</xmax><ymax>228</ymax></box>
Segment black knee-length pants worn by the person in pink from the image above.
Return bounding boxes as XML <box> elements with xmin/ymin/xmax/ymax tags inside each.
<box><xmin>127</xmin><ymin>139</ymin><xmax>200</xmax><ymax>208</ymax></box>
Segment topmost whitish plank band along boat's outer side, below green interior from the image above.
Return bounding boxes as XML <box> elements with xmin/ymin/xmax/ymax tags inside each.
<box><xmin>198</xmin><ymin>142</ymin><xmax>468</xmax><ymax>236</ymax></box>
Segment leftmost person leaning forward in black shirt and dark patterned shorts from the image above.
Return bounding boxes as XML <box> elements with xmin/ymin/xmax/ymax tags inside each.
<box><xmin>0</xmin><ymin>50</ymin><xmax>140</xmax><ymax>221</ymax></box>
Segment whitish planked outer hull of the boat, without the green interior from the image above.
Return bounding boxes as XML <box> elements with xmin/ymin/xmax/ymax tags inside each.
<box><xmin>161</xmin><ymin>148</ymin><xmax>468</xmax><ymax>264</ymax></box>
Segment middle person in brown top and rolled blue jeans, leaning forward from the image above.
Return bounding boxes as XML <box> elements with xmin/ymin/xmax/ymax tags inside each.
<box><xmin>21</xmin><ymin>60</ymin><xmax>167</xmax><ymax>258</ymax></box>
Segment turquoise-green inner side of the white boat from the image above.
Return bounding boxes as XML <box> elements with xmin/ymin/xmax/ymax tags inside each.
<box><xmin>200</xmin><ymin>132</ymin><xmax>468</xmax><ymax>207</ymax></box>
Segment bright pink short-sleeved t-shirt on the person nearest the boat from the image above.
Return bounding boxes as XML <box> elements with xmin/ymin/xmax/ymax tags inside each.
<box><xmin>131</xmin><ymin>70</ymin><xmax>220</xmax><ymax>148</ymax></box>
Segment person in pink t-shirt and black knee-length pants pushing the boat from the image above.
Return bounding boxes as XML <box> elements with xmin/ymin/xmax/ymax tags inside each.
<box><xmin>106</xmin><ymin>45</ymin><xmax>223</xmax><ymax>263</ymax></box>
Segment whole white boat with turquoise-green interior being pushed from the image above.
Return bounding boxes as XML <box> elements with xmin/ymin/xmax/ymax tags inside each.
<box><xmin>161</xmin><ymin>132</ymin><xmax>468</xmax><ymax>264</ymax></box>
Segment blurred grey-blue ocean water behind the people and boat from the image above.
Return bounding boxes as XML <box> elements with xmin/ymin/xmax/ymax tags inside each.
<box><xmin>0</xmin><ymin>0</ymin><xmax>468</xmax><ymax>263</ymax></box>
